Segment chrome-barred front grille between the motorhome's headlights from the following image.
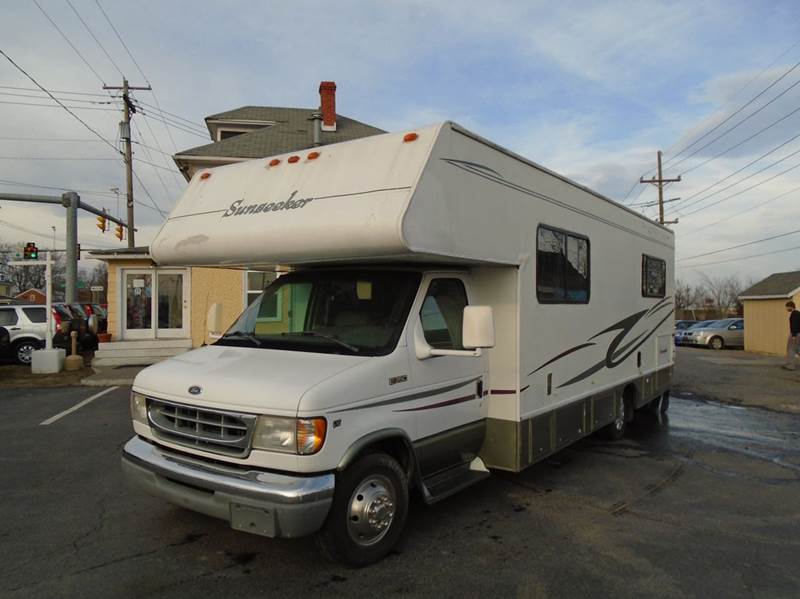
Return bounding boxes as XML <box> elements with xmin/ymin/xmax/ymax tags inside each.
<box><xmin>147</xmin><ymin>398</ymin><xmax>256</xmax><ymax>456</ymax></box>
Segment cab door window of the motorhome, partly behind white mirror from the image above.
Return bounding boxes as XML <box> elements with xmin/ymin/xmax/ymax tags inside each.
<box><xmin>419</xmin><ymin>279</ymin><xmax>467</xmax><ymax>349</ymax></box>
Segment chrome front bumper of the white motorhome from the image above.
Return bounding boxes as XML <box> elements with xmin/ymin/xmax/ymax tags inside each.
<box><xmin>122</xmin><ymin>437</ymin><xmax>335</xmax><ymax>538</ymax></box>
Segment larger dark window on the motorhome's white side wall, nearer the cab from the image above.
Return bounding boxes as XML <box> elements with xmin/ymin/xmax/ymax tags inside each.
<box><xmin>536</xmin><ymin>226</ymin><xmax>589</xmax><ymax>304</ymax></box>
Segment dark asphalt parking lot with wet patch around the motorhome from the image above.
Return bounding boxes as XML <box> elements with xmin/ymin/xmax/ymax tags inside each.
<box><xmin>0</xmin><ymin>387</ymin><xmax>800</xmax><ymax>598</ymax></box>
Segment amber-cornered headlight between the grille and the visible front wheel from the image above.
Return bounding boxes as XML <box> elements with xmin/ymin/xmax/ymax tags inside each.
<box><xmin>253</xmin><ymin>416</ymin><xmax>327</xmax><ymax>455</ymax></box>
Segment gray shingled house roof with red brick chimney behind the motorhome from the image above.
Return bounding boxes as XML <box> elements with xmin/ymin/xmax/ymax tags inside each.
<box><xmin>173</xmin><ymin>81</ymin><xmax>385</xmax><ymax>181</ymax></box>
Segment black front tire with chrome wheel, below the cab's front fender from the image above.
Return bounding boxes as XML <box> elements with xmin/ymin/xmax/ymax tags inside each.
<box><xmin>316</xmin><ymin>453</ymin><xmax>408</xmax><ymax>567</ymax></box>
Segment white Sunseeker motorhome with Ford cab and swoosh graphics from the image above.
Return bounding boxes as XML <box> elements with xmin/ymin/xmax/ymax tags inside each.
<box><xmin>123</xmin><ymin>122</ymin><xmax>674</xmax><ymax>565</ymax></box>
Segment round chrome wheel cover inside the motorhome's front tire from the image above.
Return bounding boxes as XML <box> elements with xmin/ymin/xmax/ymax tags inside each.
<box><xmin>347</xmin><ymin>474</ymin><xmax>397</xmax><ymax>547</ymax></box>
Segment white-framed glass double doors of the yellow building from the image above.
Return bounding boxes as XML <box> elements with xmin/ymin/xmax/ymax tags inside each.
<box><xmin>121</xmin><ymin>269</ymin><xmax>189</xmax><ymax>339</ymax></box>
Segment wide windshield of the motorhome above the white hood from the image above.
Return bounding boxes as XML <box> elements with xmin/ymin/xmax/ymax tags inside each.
<box><xmin>216</xmin><ymin>270</ymin><xmax>421</xmax><ymax>356</ymax></box>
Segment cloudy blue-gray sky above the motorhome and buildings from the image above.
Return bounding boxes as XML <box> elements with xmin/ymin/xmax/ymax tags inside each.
<box><xmin>0</xmin><ymin>0</ymin><xmax>800</xmax><ymax>282</ymax></box>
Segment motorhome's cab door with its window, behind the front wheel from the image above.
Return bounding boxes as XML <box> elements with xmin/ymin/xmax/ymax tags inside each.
<box><xmin>409</xmin><ymin>275</ymin><xmax>488</xmax><ymax>476</ymax></box>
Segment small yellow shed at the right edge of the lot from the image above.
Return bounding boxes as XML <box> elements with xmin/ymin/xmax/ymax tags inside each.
<box><xmin>739</xmin><ymin>270</ymin><xmax>800</xmax><ymax>356</ymax></box>
